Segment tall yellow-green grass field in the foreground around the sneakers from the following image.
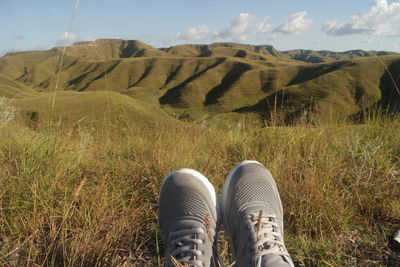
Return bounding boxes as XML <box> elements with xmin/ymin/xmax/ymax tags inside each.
<box><xmin>0</xmin><ymin>98</ymin><xmax>400</xmax><ymax>266</ymax></box>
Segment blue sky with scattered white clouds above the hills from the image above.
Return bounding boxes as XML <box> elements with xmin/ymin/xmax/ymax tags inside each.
<box><xmin>0</xmin><ymin>0</ymin><xmax>400</xmax><ymax>56</ymax></box>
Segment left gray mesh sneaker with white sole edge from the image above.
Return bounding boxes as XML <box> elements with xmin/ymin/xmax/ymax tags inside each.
<box><xmin>158</xmin><ymin>169</ymin><xmax>219</xmax><ymax>266</ymax></box>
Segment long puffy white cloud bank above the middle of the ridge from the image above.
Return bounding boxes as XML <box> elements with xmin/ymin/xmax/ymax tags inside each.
<box><xmin>175</xmin><ymin>12</ymin><xmax>312</xmax><ymax>41</ymax></box>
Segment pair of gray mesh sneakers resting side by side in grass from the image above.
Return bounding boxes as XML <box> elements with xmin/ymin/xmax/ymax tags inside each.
<box><xmin>158</xmin><ymin>161</ymin><xmax>294</xmax><ymax>266</ymax></box>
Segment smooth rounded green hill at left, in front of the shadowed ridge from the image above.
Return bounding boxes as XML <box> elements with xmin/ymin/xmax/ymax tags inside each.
<box><xmin>12</xmin><ymin>91</ymin><xmax>179</xmax><ymax>128</ymax></box>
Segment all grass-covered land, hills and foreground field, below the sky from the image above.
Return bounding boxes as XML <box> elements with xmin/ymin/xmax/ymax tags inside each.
<box><xmin>0</xmin><ymin>40</ymin><xmax>400</xmax><ymax>266</ymax></box>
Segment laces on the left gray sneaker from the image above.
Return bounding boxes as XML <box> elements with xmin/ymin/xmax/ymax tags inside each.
<box><xmin>170</xmin><ymin>228</ymin><xmax>204</xmax><ymax>266</ymax></box>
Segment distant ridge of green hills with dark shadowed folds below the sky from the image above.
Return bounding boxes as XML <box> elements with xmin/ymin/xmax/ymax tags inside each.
<box><xmin>0</xmin><ymin>39</ymin><xmax>400</xmax><ymax>126</ymax></box>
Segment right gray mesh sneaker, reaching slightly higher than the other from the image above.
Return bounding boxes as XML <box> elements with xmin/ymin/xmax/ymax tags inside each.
<box><xmin>221</xmin><ymin>161</ymin><xmax>294</xmax><ymax>266</ymax></box>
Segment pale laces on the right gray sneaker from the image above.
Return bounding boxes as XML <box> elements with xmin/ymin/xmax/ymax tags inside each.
<box><xmin>246</xmin><ymin>212</ymin><xmax>289</xmax><ymax>266</ymax></box>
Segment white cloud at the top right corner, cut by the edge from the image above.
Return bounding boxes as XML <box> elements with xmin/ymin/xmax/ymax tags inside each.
<box><xmin>322</xmin><ymin>0</ymin><xmax>400</xmax><ymax>36</ymax></box>
